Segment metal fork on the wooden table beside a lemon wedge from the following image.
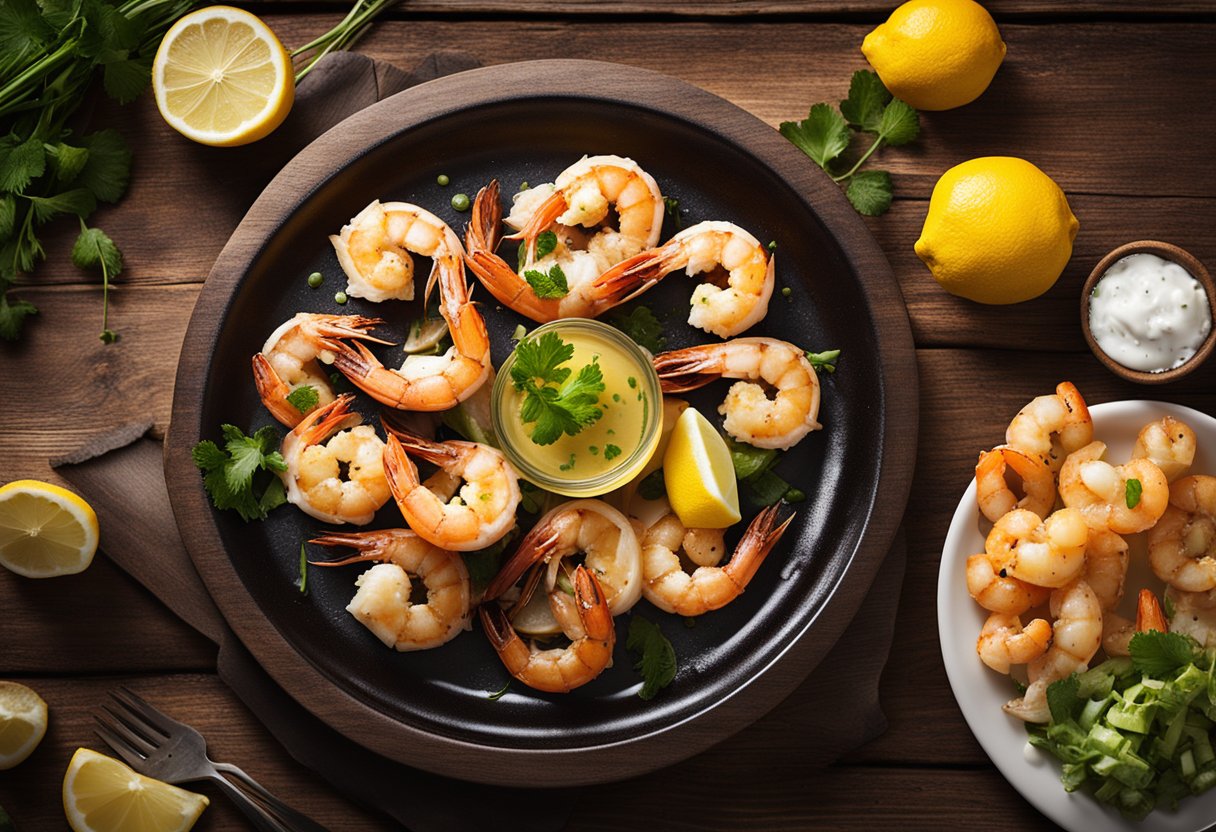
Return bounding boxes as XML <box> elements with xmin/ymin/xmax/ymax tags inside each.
<box><xmin>94</xmin><ymin>687</ymin><xmax>327</xmax><ymax>832</ymax></box>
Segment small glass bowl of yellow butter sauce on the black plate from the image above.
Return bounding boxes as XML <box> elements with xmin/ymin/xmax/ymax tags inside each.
<box><xmin>491</xmin><ymin>317</ymin><xmax>663</xmax><ymax>497</ymax></box>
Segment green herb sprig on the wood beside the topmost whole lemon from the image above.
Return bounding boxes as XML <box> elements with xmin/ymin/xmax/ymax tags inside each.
<box><xmin>779</xmin><ymin>69</ymin><xmax>921</xmax><ymax>217</ymax></box>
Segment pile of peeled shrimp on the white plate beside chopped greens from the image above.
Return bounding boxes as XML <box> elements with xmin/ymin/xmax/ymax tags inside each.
<box><xmin>967</xmin><ymin>382</ymin><xmax>1216</xmax><ymax>723</ymax></box>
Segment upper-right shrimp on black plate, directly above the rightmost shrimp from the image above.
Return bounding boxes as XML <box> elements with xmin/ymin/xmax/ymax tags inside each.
<box><xmin>592</xmin><ymin>221</ymin><xmax>776</xmax><ymax>338</ymax></box>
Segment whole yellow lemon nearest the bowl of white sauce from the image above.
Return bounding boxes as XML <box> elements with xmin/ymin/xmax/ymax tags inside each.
<box><xmin>916</xmin><ymin>156</ymin><xmax>1080</xmax><ymax>304</ymax></box>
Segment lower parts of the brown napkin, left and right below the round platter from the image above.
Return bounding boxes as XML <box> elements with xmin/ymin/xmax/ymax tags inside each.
<box><xmin>51</xmin><ymin>425</ymin><xmax>906</xmax><ymax>817</ymax></box>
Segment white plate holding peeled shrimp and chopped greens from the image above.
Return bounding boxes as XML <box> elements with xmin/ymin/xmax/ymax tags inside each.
<box><xmin>938</xmin><ymin>401</ymin><xmax>1216</xmax><ymax>832</ymax></box>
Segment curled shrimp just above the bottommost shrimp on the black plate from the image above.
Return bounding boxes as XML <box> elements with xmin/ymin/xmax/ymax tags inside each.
<box><xmin>485</xmin><ymin>500</ymin><xmax>642</xmax><ymax>639</ymax></box>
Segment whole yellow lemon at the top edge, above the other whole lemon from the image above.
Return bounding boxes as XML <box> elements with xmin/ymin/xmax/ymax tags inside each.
<box><xmin>861</xmin><ymin>0</ymin><xmax>1004</xmax><ymax>109</ymax></box>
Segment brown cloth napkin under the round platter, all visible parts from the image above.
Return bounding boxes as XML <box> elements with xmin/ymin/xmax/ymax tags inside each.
<box><xmin>51</xmin><ymin>51</ymin><xmax>906</xmax><ymax>832</ymax></box>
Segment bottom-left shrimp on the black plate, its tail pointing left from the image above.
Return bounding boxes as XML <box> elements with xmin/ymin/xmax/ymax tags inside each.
<box><xmin>309</xmin><ymin>529</ymin><xmax>469</xmax><ymax>652</ymax></box>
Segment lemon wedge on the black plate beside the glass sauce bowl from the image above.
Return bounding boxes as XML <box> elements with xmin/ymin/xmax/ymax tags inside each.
<box><xmin>663</xmin><ymin>407</ymin><xmax>741</xmax><ymax>529</ymax></box>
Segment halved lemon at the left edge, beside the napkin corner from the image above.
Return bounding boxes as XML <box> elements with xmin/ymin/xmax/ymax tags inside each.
<box><xmin>0</xmin><ymin>479</ymin><xmax>97</xmax><ymax>578</ymax></box>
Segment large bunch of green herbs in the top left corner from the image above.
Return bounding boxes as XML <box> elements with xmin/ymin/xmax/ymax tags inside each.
<box><xmin>0</xmin><ymin>0</ymin><xmax>196</xmax><ymax>343</ymax></box>
